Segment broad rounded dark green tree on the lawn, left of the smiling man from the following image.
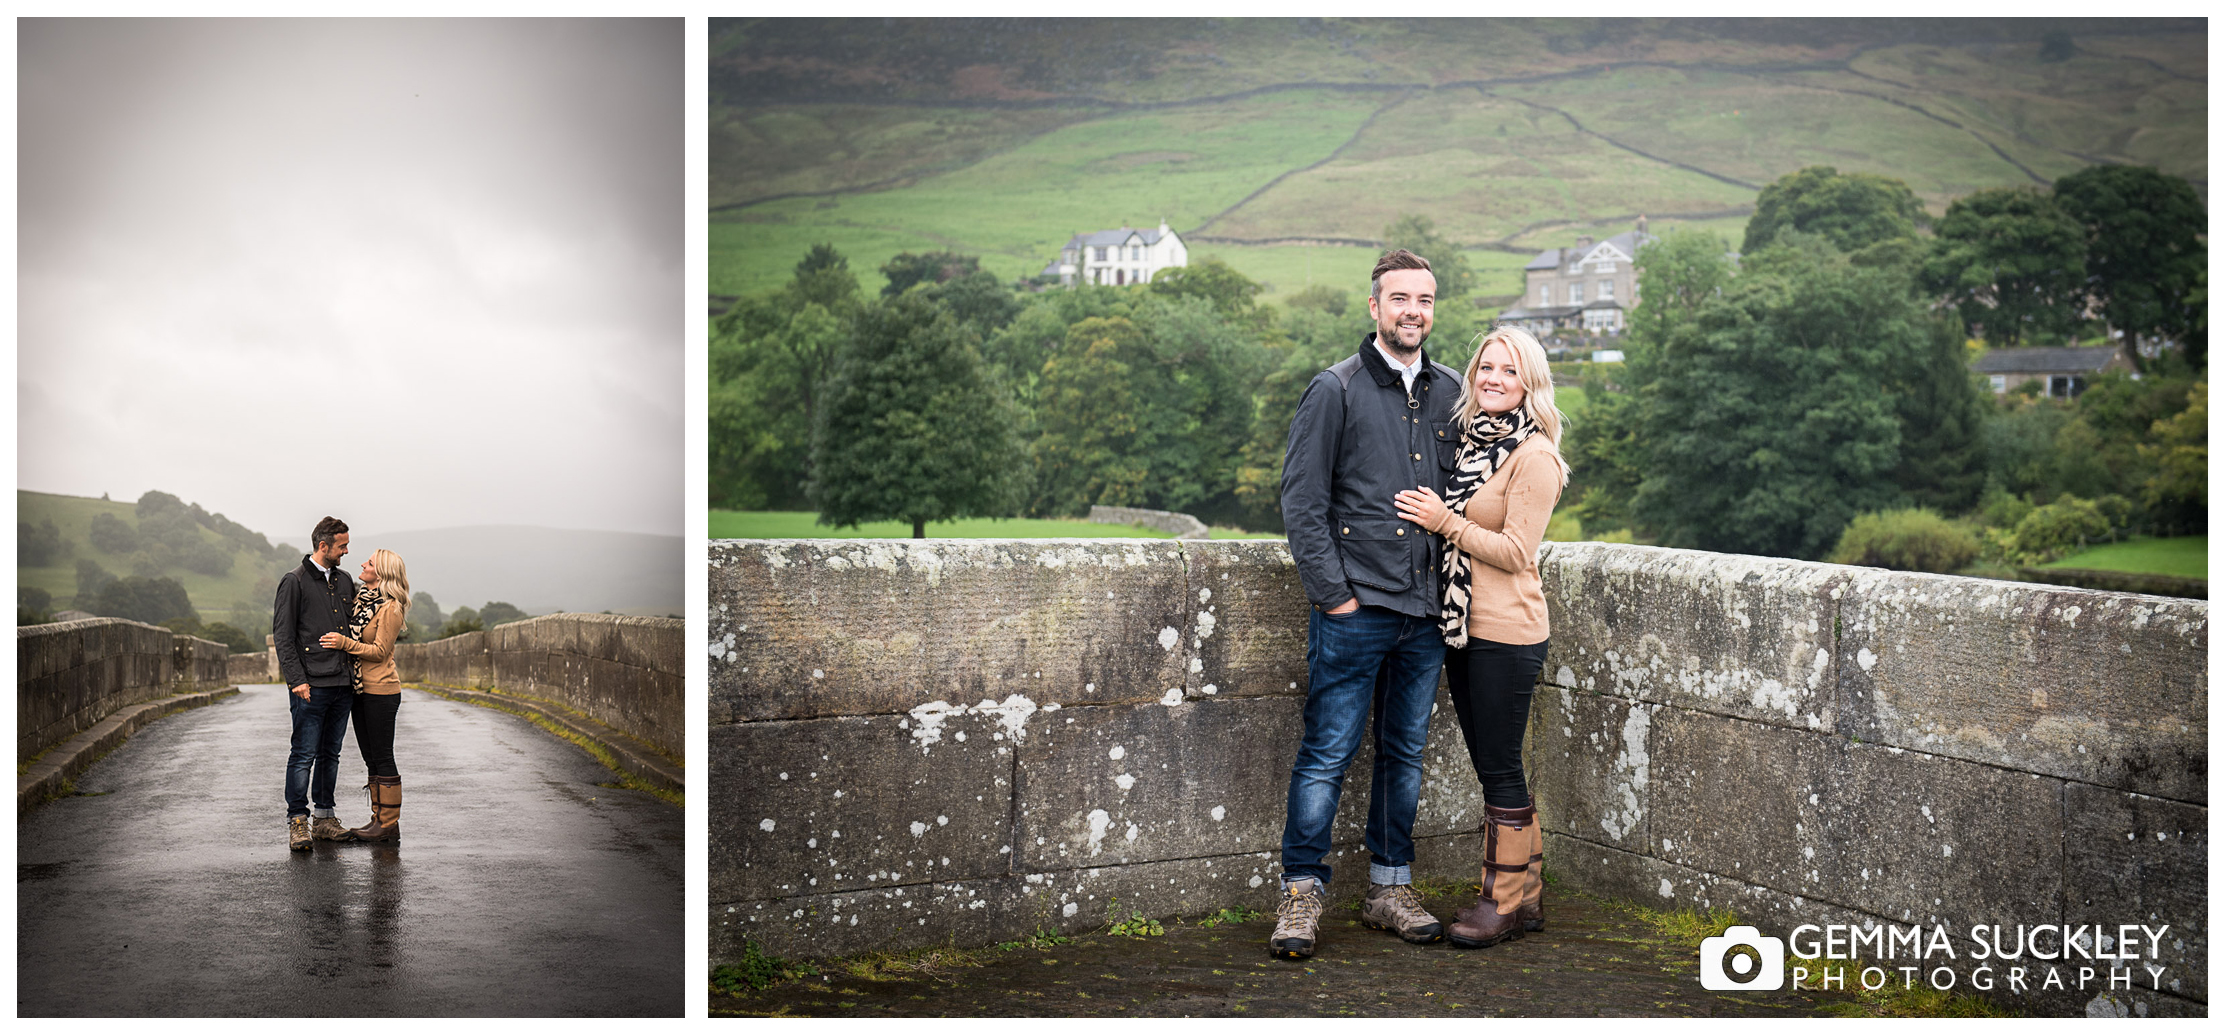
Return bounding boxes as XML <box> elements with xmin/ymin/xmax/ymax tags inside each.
<box><xmin>810</xmin><ymin>292</ymin><xmax>1028</xmax><ymax>539</ymax></box>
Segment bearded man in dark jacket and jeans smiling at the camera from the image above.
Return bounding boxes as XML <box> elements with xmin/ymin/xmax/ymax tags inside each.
<box><xmin>1269</xmin><ymin>250</ymin><xmax>1460</xmax><ymax>960</ymax></box>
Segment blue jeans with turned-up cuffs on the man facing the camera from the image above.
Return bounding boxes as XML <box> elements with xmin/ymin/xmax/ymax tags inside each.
<box><xmin>1282</xmin><ymin>606</ymin><xmax>1445</xmax><ymax>884</ymax></box>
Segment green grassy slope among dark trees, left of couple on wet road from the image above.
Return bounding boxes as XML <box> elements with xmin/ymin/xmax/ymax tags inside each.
<box><xmin>16</xmin><ymin>490</ymin><xmax>307</xmax><ymax>635</ymax></box>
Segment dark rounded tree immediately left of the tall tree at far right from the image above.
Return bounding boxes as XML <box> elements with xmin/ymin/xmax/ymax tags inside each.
<box><xmin>1921</xmin><ymin>187</ymin><xmax>2086</xmax><ymax>345</ymax></box>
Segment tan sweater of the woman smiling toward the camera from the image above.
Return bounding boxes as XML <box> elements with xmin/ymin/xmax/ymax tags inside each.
<box><xmin>1431</xmin><ymin>434</ymin><xmax>1560</xmax><ymax>644</ymax></box>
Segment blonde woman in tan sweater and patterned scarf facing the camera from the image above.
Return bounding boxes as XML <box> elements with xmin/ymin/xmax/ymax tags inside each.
<box><xmin>1393</xmin><ymin>328</ymin><xmax>1569</xmax><ymax>949</ymax></box>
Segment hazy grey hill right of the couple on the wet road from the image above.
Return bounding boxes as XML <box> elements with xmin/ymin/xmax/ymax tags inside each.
<box><xmin>362</xmin><ymin>526</ymin><xmax>683</xmax><ymax>615</ymax></box>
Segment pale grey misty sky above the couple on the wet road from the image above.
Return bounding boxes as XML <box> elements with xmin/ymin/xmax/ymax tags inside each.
<box><xmin>16</xmin><ymin>18</ymin><xmax>686</xmax><ymax>544</ymax></box>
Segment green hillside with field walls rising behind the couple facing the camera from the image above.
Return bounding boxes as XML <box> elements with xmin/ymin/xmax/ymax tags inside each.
<box><xmin>710</xmin><ymin>18</ymin><xmax>2208</xmax><ymax>299</ymax></box>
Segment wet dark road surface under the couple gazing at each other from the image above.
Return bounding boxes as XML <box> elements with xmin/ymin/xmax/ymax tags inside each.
<box><xmin>16</xmin><ymin>684</ymin><xmax>686</xmax><ymax>1016</ymax></box>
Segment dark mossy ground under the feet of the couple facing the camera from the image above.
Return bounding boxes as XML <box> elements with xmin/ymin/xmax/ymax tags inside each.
<box><xmin>710</xmin><ymin>884</ymin><xmax>1848</xmax><ymax>1018</ymax></box>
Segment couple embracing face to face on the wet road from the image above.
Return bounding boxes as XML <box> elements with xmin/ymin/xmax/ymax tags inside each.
<box><xmin>272</xmin><ymin>515</ymin><xmax>410</xmax><ymax>851</ymax></box>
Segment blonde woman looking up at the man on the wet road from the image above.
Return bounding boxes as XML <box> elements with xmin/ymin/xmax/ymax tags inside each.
<box><xmin>318</xmin><ymin>550</ymin><xmax>410</xmax><ymax>842</ymax></box>
